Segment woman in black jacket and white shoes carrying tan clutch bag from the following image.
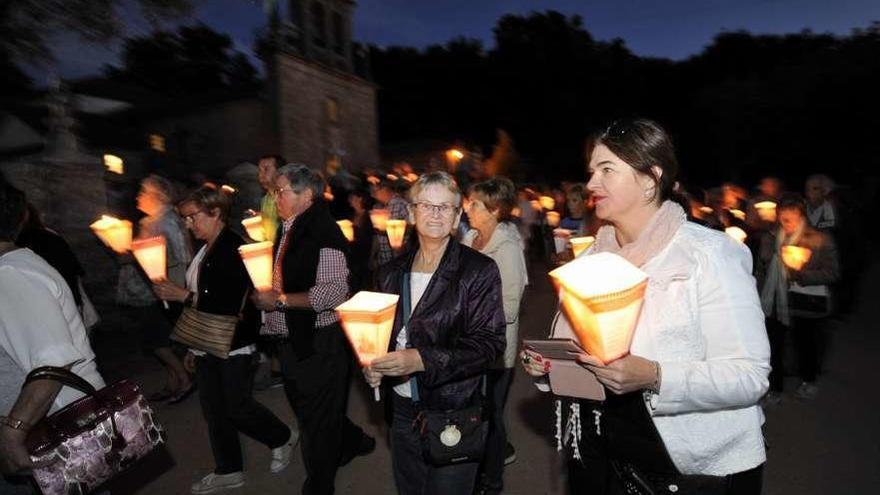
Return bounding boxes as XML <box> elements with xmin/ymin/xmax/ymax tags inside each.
<box><xmin>153</xmin><ymin>184</ymin><xmax>292</xmax><ymax>494</ymax></box>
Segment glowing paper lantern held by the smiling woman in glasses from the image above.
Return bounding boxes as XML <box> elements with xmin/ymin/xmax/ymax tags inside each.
<box><xmin>336</xmin><ymin>291</ymin><xmax>399</xmax><ymax>400</ymax></box>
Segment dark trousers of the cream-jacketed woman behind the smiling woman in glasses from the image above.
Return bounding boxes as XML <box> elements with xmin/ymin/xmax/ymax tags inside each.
<box><xmin>480</xmin><ymin>368</ymin><xmax>513</xmax><ymax>493</ymax></box>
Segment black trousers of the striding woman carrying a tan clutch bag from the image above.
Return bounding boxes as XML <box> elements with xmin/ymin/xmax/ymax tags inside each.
<box><xmin>196</xmin><ymin>354</ymin><xmax>290</xmax><ymax>474</ymax></box>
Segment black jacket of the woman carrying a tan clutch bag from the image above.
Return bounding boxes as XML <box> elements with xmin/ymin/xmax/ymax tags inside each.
<box><xmin>195</xmin><ymin>227</ymin><xmax>260</xmax><ymax>350</ymax></box>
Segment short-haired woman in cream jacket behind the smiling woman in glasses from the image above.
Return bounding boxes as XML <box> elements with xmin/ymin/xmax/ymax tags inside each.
<box><xmin>462</xmin><ymin>177</ymin><xmax>529</xmax><ymax>494</ymax></box>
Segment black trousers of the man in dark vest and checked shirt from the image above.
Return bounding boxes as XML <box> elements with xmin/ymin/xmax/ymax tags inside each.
<box><xmin>279</xmin><ymin>324</ymin><xmax>364</xmax><ymax>495</ymax></box>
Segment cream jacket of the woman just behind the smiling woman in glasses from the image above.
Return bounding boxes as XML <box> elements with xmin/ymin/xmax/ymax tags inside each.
<box><xmin>461</xmin><ymin>222</ymin><xmax>529</xmax><ymax>368</ymax></box>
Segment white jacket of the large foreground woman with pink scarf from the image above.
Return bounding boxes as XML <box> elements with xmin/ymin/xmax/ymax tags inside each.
<box><xmin>561</xmin><ymin>222</ymin><xmax>770</xmax><ymax>476</ymax></box>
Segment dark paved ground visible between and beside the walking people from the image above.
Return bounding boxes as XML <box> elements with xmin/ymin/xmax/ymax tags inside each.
<box><xmin>95</xmin><ymin>252</ymin><xmax>880</xmax><ymax>495</ymax></box>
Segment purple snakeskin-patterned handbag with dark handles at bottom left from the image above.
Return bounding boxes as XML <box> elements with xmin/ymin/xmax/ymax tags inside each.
<box><xmin>24</xmin><ymin>366</ymin><xmax>165</xmax><ymax>495</ymax></box>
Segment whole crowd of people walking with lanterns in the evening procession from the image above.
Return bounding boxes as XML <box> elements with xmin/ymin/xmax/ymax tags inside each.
<box><xmin>0</xmin><ymin>119</ymin><xmax>864</xmax><ymax>495</ymax></box>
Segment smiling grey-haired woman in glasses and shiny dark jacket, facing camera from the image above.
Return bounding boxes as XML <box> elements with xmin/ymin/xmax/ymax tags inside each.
<box><xmin>364</xmin><ymin>172</ymin><xmax>505</xmax><ymax>495</ymax></box>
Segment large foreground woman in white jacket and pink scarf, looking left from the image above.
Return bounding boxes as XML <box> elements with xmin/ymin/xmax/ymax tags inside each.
<box><xmin>522</xmin><ymin>120</ymin><xmax>770</xmax><ymax>495</ymax></box>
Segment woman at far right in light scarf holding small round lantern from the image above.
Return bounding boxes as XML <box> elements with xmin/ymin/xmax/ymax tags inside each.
<box><xmin>755</xmin><ymin>196</ymin><xmax>840</xmax><ymax>405</ymax></box>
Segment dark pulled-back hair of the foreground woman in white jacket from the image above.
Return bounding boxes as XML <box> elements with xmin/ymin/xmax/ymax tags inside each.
<box><xmin>586</xmin><ymin>118</ymin><xmax>678</xmax><ymax>202</ymax></box>
